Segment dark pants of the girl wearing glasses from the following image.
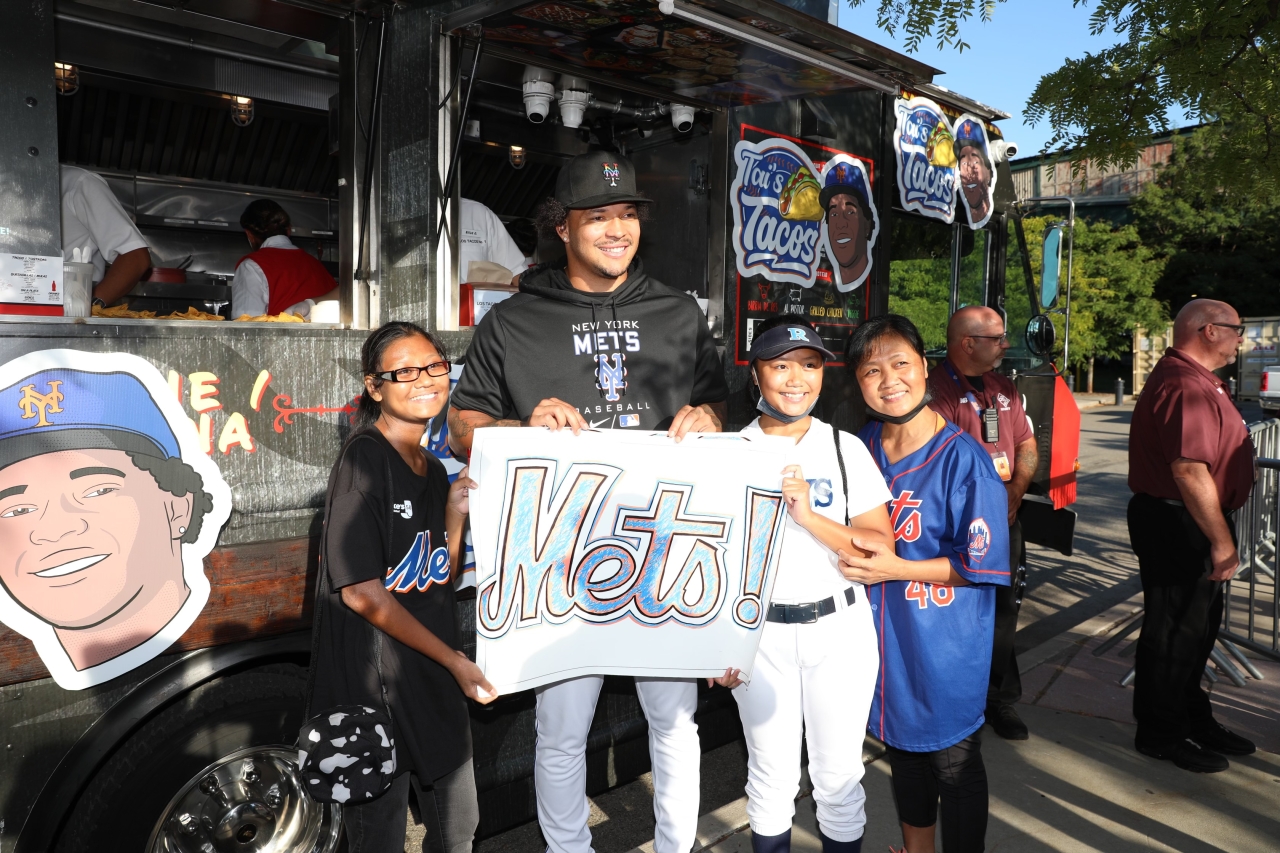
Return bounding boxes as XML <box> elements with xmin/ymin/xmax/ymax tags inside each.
<box><xmin>342</xmin><ymin>761</ymin><xmax>480</xmax><ymax>853</ymax></box>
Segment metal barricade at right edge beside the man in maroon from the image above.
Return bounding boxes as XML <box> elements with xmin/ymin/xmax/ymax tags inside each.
<box><xmin>1215</xmin><ymin>420</ymin><xmax>1280</xmax><ymax>678</ymax></box>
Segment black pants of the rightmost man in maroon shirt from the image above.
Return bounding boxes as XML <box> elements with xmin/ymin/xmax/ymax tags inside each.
<box><xmin>1129</xmin><ymin>494</ymin><xmax>1235</xmax><ymax>747</ymax></box>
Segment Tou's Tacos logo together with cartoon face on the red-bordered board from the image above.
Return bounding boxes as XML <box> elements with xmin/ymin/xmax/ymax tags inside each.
<box><xmin>730</xmin><ymin>138</ymin><xmax>879</xmax><ymax>286</ymax></box>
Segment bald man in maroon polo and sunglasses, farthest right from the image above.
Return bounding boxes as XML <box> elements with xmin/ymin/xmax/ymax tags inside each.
<box><xmin>1129</xmin><ymin>300</ymin><xmax>1253</xmax><ymax>772</ymax></box>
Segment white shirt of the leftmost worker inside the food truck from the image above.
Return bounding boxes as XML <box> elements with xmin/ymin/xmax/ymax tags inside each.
<box><xmin>61</xmin><ymin>165</ymin><xmax>147</xmax><ymax>283</ymax></box>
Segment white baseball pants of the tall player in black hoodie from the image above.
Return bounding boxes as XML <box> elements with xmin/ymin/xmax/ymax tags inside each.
<box><xmin>534</xmin><ymin>675</ymin><xmax>706</xmax><ymax>853</ymax></box>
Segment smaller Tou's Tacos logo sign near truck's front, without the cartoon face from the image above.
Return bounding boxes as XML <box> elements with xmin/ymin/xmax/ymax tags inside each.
<box><xmin>893</xmin><ymin>97</ymin><xmax>956</xmax><ymax>223</ymax></box>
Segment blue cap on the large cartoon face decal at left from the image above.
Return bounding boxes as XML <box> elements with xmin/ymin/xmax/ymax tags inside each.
<box><xmin>0</xmin><ymin>368</ymin><xmax>182</xmax><ymax>467</ymax></box>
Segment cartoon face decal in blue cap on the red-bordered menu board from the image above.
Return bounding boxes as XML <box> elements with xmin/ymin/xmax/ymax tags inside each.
<box><xmin>818</xmin><ymin>154</ymin><xmax>879</xmax><ymax>292</ymax></box>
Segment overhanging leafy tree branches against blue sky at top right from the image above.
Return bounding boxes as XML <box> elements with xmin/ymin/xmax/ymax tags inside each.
<box><xmin>847</xmin><ymin>0</ymin><xmax>1280</xmax><ymax>197</ymax></box>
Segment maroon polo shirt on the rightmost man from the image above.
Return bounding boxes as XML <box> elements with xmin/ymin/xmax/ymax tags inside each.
<box><xmin>1129</xmin><ymin>348</ymin><xmax>1253</xmax><ymax>510</ymax></box>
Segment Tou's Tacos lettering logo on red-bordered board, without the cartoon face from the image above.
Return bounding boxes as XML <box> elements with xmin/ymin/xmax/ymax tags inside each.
<box><xmin>730</xmin><ymin>138</ymin><xmax>822</xmax><ymax>287</ymax></box>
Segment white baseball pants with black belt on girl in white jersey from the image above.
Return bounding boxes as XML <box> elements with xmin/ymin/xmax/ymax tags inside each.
<box><xmin>733</xmin><ymin>596</ymin><xmax>879</xmax><ymax>841</ymax></box>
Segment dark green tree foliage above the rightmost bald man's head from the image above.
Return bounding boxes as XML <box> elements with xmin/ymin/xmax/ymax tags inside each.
<box><xmin>1133</xmin><ymin>127</ymin><xmax>1280</xmax><ymax>316</ymax></box>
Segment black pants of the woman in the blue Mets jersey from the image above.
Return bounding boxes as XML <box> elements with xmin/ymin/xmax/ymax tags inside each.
<box><xmin>888</xmin><ymin>729</ymin><xmax>987</xmax><ymax>853</ymax></box>
